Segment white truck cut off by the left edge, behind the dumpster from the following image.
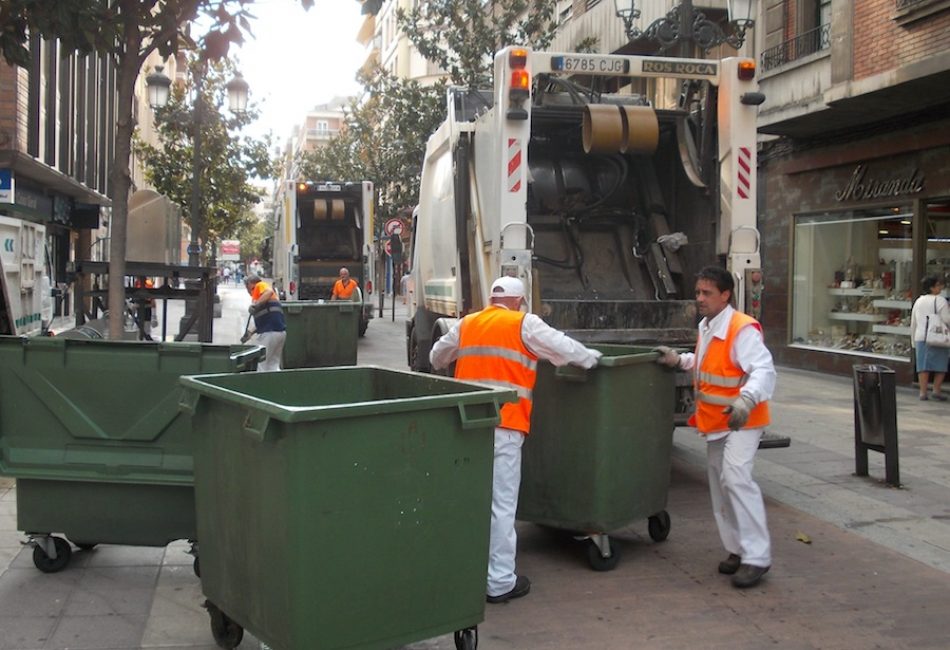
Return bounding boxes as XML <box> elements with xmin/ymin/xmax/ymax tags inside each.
<box><xmin>0</xmin><ymin>216</ymin><xmax>53</xmax><ymax>336</ymax></box>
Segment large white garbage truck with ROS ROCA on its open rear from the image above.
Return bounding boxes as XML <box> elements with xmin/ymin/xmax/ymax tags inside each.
<box><xmin>406</xmin><ymin>47</ymin><xmax>764</xmax><ymax>424</ymax></box>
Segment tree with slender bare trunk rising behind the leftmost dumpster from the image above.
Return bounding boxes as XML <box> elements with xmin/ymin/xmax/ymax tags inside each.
<box><xmin>0</xmin><ymin>0</ymin><xmax>313</xmax><ymax>339</ymax></box>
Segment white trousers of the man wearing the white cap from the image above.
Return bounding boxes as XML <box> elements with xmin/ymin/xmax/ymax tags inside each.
<box><xmin>487</xmin><ymin>427</ymin><xmax>524</xmax><ymax>596</ymax></box>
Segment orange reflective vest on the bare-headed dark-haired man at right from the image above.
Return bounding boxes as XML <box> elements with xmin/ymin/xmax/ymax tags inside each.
<box><xmin>689</xmin><ymin>311</ymin><xmax>769</xmax><ymax>435</ymax></box>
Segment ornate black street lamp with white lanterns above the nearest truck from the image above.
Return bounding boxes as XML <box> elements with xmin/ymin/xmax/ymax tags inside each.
<box><xmin>614</xmin><ymin>0</ymin><xmax>755</xmax><ymax>52</ymax></box>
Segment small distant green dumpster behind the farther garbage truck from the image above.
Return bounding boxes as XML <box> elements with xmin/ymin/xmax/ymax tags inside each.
<box><xmin>281</xmin><ymin>300</ymin><xmax>362</xmax><ymax>369</ymax></box>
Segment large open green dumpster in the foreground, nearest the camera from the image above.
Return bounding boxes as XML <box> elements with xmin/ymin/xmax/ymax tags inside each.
<box><xmin>181</xmin><ymin>366</ymin><xmax>515</xmax><ymax>650</ymax></box>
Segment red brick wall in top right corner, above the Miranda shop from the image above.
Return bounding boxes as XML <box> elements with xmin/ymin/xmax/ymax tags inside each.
<box><xmin>854</xmin><ymin>0</ymin><xmax>950</xmax><ymax>80</ymax></box>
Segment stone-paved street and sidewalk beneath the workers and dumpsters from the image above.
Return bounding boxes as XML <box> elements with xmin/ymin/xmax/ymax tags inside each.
<box><xmin>0</xmin><ymin>290</ymin><xmax>950</xmax><ymax>650</ymax></box>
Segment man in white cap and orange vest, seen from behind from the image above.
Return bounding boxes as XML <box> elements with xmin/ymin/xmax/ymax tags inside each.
<box><xmin>429</xmin><ymin>276</ymin><xmax>601</xmax><ymax>603</ymax></box>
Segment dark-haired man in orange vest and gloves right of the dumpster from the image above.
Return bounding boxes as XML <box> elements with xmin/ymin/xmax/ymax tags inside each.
<box><xmin>656</xmin><ymin>266</ymin><xmax>775</xmax><ymax>589</ymax></box>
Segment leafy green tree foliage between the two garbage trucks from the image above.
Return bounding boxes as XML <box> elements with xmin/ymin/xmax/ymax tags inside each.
<box><xmin>298</xmin><ymin>68</ymin><xmax>445</xmax><ymax>223</ymax></box>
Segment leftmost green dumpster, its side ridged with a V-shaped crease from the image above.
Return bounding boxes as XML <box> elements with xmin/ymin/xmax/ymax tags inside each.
<box><xmin>0</xmin><ymin>336</ymin><xmax>264</xmax><ymax>572</ymax></box>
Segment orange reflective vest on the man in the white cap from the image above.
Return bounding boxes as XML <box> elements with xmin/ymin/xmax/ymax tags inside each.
<box><xmin>455</xmin><ymin>305</ymin><xmax>538</xmax><ymax>435</ymax></box>
